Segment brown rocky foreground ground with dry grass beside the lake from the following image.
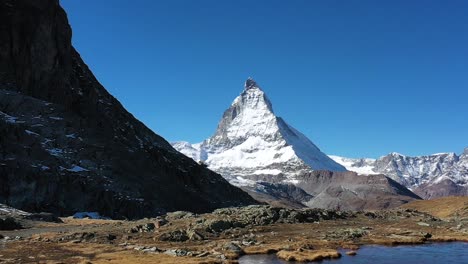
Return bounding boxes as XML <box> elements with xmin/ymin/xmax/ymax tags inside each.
<box><xmin>0</xmin><ymin>197</ymin><xmax>468</xmax><ymax>264</ymax></box>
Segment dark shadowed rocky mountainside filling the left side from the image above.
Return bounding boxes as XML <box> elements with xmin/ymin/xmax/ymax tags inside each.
<box><xmin>0</xmin><ymin>0</ymin><xmax>255</xmax><ymax>218</ymax></box>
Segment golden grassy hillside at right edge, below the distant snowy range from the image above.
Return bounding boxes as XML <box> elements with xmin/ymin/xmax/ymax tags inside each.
<box><xmin>401</xmin><ymin>196</ymin><xmax>468</xmax><ymax>218</ymax></box>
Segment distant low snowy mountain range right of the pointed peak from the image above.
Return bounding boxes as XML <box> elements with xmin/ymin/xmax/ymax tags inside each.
<box><xmin>330</xmin><ymin>148</ymin><xmax>468</xmax><ymax>199</ymax></box>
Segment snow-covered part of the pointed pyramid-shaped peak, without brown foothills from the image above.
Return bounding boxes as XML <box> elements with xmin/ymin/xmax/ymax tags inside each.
<box><xmin>173</xmin><ymin>78</ymin><xmax>346</xmax><ymax>185</ymax></box>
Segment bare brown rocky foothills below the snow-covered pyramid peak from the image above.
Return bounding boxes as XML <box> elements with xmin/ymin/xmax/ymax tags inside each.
<box><xmin>242</xmin><ymin>171</ymin><xmax>421</xmax><ymax>210</ymax></box>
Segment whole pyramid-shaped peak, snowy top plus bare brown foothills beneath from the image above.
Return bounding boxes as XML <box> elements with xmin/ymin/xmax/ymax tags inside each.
<box><xmin>173</xmin><ymin>78</ymin><xmax>420</xmax><ymax>210</ymax></box>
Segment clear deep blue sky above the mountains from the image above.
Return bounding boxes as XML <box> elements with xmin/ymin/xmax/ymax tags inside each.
<box><xmin>61</xmin><ymin>0</ymin><xmax>468</xmax><ymax>157</ymax></box>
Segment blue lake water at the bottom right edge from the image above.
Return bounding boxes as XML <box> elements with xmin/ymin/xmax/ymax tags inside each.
<box><xmin>239</xmin><ymin>242</ymin><xmax>468</xmax><ymax>264</ymax></box>
